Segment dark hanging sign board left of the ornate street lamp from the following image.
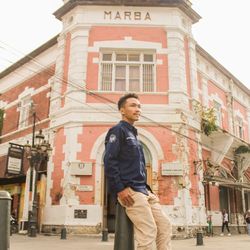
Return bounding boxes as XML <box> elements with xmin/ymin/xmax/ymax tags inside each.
<box><xmin>6</xmin><ymin>143</ymin><xmax>24</xmax><ymax>174</ymax></box>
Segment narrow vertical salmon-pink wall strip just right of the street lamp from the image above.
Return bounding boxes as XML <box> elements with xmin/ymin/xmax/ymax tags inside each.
<box><xmin>50</xmin><ymin>128</ymin><xmax>66</xmax><ymax>205</ymax></box>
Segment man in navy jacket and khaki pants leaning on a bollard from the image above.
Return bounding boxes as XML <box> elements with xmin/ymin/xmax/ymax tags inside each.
<box><xmin>104</xmin><ymin>94</ymin><xmax>172</xmax><ymax>250</ymax></box>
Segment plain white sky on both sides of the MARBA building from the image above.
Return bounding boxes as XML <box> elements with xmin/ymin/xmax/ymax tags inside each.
<box><xmin>0</xmin><ymin>0</ymin><xmax>250</xmax><ymax>89</ymax></box>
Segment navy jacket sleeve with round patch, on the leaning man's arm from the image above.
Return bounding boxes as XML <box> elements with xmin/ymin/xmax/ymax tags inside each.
<box><xmin>104</xmin><ymin>127</ymin><xmax>125</xmax><ymax>193</ymax></box>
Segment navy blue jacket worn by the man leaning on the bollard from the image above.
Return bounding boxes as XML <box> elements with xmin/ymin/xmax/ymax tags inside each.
<box><xmin>104</xmin><ymin>121</ymin><xmax>148</xmax><ymax>194</ymax></box>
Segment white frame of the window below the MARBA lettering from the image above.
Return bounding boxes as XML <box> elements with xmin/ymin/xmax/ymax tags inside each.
<box><xmin>98</xmin><ymin>49</ymin><xmax>157</xmax><ymax>93</ymax></box>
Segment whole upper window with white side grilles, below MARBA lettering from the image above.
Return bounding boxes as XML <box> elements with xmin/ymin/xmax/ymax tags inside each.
<box><xmin>100</xmin><ymin>52</ymin><xmax>155</xmax><ymax>92</ymax></box>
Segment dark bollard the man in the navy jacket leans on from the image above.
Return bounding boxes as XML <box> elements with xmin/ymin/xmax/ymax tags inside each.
<box><xmin>114</xmin><ymin>202</ymin><xmax>135</xmax><ymax>250</ymax></box>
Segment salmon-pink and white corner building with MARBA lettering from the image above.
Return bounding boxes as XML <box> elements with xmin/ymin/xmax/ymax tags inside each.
<box><xmin>0</xmin><ymin>0</ymin><xmax>250</xmax><ymax>234</ymax></box>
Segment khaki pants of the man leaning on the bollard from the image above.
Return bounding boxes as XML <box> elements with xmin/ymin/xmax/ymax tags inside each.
<box><xmin>119</xmin><ymin>189</ymin><xmax>172</xmax><ymax>250</ymax></box>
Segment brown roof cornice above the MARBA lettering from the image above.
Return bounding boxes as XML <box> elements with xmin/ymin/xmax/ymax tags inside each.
<box><xmin>54</xmin><ymin>0</ymin><xmax>201</xmax><ymax>23</ymax></box>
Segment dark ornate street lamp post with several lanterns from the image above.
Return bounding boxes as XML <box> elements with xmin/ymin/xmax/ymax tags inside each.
<box><xmin>24</xmin><ymin>130</ymin><xmax>51</xmax><ymax>237</ymax></box>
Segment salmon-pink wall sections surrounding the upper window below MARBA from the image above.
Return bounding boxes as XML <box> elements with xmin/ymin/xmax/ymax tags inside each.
<box><xmin>86</xmin><ymin>27</ymin><xmax>169</xmax><ymax>104</ymax></box>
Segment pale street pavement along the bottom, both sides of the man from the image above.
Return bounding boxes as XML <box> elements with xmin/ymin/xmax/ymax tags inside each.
<box><xmin>10</xmin><ymin>234</ymin><xmax>250</xmax><ymax>250</ymax></box>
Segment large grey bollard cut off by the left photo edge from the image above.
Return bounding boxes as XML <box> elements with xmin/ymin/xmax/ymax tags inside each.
<box><xmin>0</xmin><ymin>191</ymin><xmax>11</xmax><ymax>250</ymax></box>
